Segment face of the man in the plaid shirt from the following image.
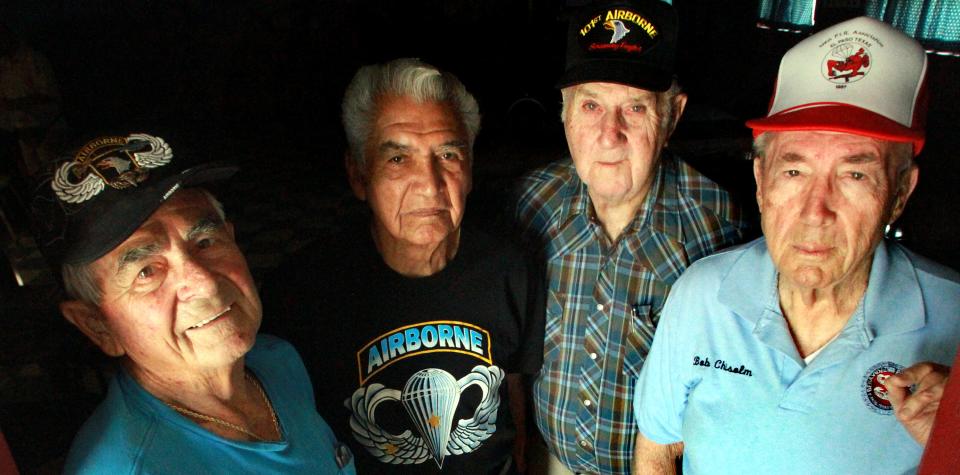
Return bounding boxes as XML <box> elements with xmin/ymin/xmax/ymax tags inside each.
<box><xmin>564</xmin><ymin>82</ymin><xmax>682</xmax><ymax>204</ymax></box>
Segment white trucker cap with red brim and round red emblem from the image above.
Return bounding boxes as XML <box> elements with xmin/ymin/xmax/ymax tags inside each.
<box><xmin>747</xmin><ymin>17</ymin><xmax>927</xmax><ymax>156</ymax></box>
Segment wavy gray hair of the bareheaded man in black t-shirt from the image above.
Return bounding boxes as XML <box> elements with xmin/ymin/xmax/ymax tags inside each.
<box><xmin>342</xmin><ymin>58</ymin><xmax>480</xmax><ymax>170</ymax></box>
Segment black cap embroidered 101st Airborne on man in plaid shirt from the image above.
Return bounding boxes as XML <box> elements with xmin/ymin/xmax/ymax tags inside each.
<box><xmin>556</xmin><ymin>0</ymin><xmax>677</xmax><ymax>92</ymax></box>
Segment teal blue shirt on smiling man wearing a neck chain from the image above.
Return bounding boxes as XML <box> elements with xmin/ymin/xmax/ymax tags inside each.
<box><xmin>64</xmin><ymin>335</ymin><xmax>354</xmax><ymax>474</ymax></box>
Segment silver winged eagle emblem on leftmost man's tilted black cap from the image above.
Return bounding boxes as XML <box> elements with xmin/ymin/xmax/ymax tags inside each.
<box><xmin>50</xmin><ymin>134</ymin><xmax>173</xmax><ymax>203</ymax></box>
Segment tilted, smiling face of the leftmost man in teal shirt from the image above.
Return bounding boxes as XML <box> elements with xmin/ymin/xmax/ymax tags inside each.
<box><xmin>91</xmin><ymin>189</ymin><xmax>261</xmax><ymax>372</ymax></box>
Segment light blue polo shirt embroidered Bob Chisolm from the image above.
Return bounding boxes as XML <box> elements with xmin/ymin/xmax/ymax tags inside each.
<box><xmin>634</xmin><ymin>238</ymin><xmax>960</xmax><ymax>475</ymax></box>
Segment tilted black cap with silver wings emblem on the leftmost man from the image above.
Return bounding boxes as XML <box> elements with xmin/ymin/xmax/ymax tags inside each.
<box><xmin>30</xmin><ymin>133</ymin><xmax>239</xmax><ymax>270</ymax></box>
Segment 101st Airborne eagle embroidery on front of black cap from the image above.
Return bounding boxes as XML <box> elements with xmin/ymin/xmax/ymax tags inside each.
<box><xmin>579</xmin><ymin>8</ymin><xmax>660</xmax><ymax>55</ymax></box>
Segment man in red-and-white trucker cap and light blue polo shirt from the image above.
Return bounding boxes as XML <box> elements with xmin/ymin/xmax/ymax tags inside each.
<box><xmin>635</xmin><ymin>17</ymin><xmax>960</xmax><ymax>474</ymax></box>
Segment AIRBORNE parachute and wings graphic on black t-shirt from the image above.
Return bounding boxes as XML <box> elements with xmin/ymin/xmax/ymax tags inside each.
<box><xmin>345</xmin><ymin>321</ymin><xmax>505</xmax><ymax>468</ymax></box>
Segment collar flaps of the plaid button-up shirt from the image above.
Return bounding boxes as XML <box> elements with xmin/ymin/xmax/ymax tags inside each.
<box><xmin>551</xmin><ymin>154</ymin><xmax>683</xmax><ymax>257</ymax></box>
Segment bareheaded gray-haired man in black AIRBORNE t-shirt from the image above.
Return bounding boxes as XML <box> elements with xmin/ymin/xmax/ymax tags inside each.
<box><xmin>264</xmin><ymin>59</ymin><xmax>543</xmax><ymax>474</ymax></box>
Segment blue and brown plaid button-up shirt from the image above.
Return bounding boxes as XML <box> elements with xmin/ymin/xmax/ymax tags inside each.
<box><xmin>516</xmin><ymin>151</ymin><xmax>744</xmax><ymax>474</ymax></box>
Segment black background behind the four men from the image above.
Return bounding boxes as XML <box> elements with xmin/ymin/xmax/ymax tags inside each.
<box><xmin>0</xmin><ymin>0</ymin><xmax>960</xmax><ymax>473</ymax></box>
